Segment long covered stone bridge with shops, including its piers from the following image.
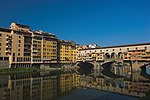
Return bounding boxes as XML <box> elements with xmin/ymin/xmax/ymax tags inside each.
<box><xmin>77</xmin><ymin>43</ymin><xmax>150</xmax><ymax>77</ymax></box>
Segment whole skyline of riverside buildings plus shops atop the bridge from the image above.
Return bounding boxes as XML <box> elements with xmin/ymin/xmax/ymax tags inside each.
<box><xmin>0</xmin><ymin>22</ymin><xmax>150</xmax><ymax>68</ymax></box>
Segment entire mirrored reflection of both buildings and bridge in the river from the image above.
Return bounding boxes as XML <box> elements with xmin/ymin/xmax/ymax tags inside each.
<box><xmin>0</xmin><ymin>70</ymin><xmax>150</xmax><ymax>100</ymax></box>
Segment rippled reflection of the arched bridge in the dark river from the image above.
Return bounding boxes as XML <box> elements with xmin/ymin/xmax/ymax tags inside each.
<box><xmin>79</xmin><ymin>70</ymin><xmax>150</xmax><ymax>97</ymax></box>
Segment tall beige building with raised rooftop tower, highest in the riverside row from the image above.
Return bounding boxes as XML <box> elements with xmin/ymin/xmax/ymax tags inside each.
<box><xmin>10</xmin><ymin>23</ymin><xmax>33</xmax><ymax>67</ymax></box>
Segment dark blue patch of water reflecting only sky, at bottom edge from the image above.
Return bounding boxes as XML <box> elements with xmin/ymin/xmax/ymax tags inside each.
<box><xmin>58</xmin><ymin>88</ymin><xmax>139</xmax><ymax>100</ymax></box>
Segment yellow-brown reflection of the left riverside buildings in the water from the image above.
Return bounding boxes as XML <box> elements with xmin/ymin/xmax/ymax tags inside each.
<box><xmin>0</xmin><ymin>71</ymin><xmax>78</xmax><ymax>100</ymax></box>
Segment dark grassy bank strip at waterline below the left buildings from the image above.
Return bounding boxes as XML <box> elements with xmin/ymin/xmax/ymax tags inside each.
<box><xmin>0</xmin><ymin>68</ymin><xmax>41</xmax><ymax>74</ymax></box>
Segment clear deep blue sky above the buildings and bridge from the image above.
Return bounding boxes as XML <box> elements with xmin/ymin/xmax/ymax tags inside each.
<box><xmin>0</xmin><ymin>0</ymin><xmax>150</xmax><ymax>46</ymax></box>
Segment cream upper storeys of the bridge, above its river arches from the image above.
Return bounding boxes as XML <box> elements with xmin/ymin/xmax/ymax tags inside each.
<box><xmin>78</xmin><ymin>43</ymin><xmax>150</xmax><ymax>61</ymax></box>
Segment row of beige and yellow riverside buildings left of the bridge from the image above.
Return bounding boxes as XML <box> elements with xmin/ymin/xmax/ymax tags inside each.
<box><xmin>0</xmin><ymin>23</ymin><xmax>76</xmax><ymax>68</ymax></box>
